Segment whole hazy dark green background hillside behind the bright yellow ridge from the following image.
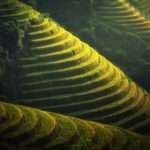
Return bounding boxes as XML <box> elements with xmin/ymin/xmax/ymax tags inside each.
<box><xmin>27</xmin><ymin>0</ymin><xmax>150</xmax><ymax>90</ymax></box>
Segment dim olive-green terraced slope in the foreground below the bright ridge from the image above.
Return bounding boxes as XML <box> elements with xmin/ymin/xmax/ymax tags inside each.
<box><xmin>0</xmin><ymin>102</ymin><xmax>150</xmax><ymax>150</ymax></box>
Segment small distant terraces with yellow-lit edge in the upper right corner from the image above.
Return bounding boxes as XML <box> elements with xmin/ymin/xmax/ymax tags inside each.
<box><xmin>94</xmin><ymin>0</ymin><xmax>150</xmax><ymax>41</ymax></box>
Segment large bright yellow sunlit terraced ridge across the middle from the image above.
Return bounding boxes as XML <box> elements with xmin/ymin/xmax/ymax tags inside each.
<box><xmin>0</xmin><ymin>0</ymin><xmax>150</xmax><ymax>135</ymax></box>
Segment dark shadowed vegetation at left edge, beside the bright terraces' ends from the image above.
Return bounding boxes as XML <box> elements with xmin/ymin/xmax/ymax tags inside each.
<box><xmin>0</xmin><ymin>19</ymin><xmax>24</xmax><ymax>97</ymax></box>
